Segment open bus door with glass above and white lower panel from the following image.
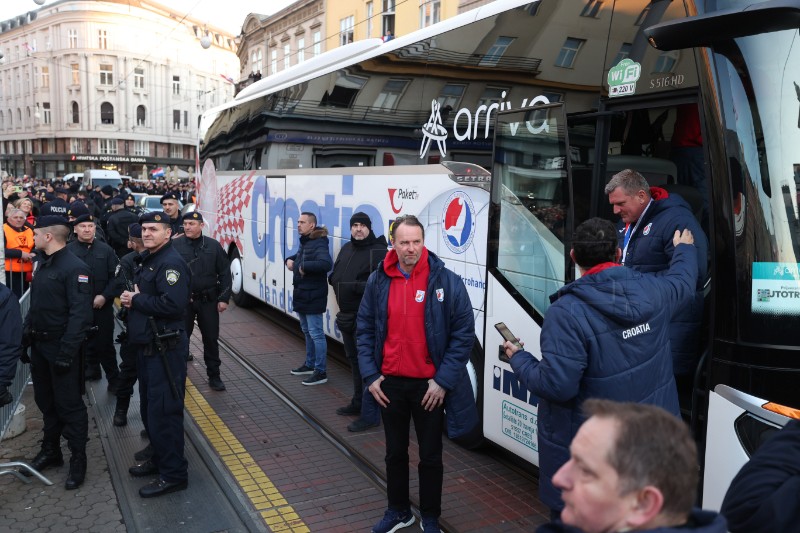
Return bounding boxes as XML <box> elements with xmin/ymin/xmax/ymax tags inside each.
<box><xmin>482</xmin><ymin>103</ymin><xmax>573</xmax><ymax>465</ymax></box>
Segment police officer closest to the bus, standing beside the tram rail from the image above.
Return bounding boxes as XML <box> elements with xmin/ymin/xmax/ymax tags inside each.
<box><xmin>175</xmin><ymin>211</ymin><xmax>231</xmax><ymax>391</ymax></box>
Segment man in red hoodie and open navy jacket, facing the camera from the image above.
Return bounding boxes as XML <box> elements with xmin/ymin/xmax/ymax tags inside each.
<box><xmin>356</xmin><ymin>215</ymin><xmax>478</xmax><ymax>533</ymax></box>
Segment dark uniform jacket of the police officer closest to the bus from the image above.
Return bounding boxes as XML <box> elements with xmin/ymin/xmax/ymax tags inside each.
<box><xmin>172</xmin><ymin>235</ymin><xmax>231</xmax><ymax>303</ymax></box>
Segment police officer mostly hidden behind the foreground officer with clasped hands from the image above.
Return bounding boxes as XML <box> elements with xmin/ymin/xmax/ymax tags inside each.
<box><xmin>114</xmin><ymin>222</ymin><xmax>145</xmax><ymax>426</ymax></box>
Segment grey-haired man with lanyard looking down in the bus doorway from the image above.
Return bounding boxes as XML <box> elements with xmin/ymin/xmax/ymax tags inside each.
<box><xmin>605</xmin><ymin>169</ymin><xmax>708</xmax><ymax>392</ymax></box>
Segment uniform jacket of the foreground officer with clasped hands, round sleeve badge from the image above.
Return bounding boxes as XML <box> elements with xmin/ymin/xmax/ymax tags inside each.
<box><xmin>128</xmin><ymin>241</ymin><xmax>192</xmax><ymax>344</ymax></box>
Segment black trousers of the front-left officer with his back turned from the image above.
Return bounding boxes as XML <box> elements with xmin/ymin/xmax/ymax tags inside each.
<box><xmin>31</xmin><ymin>339</ymin><xmax>89</xmax><ymax>450</ymax></box>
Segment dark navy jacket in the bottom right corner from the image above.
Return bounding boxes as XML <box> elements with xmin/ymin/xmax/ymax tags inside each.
<box><xmin>720</xmin><ymin>420</ymin><xmax>800</xmax><ymax>533</ymax></box>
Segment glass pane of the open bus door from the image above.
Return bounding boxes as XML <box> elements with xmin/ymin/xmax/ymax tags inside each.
<box><xmin>492</xmin><ymin>104</ymin><xmax>568</xmax><ymax>315</ymax></box>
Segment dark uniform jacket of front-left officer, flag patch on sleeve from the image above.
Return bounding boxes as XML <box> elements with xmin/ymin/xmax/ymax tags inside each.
<box><xmin>23</xmin><ymin>246</ymin><xmax>93</xmax><ymax>361</ymax></box>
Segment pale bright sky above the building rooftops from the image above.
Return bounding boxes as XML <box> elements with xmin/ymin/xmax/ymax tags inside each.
<box><xmin>0</xmin><ymin>0</ymin><xmax>294</xmax><ymax>35</ymax></box>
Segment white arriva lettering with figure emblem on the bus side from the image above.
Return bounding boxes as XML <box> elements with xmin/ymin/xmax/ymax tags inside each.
<box><xmin>419</xmin><ymin>91</ymin><xmax>550</xmax><ymax>159</ymax></box>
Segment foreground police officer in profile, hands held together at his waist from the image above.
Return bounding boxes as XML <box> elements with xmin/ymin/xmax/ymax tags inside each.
<box><xmin>120</xmin><ymin>211</ymin><xmax>191</xmax><ymax>498</ymax></box>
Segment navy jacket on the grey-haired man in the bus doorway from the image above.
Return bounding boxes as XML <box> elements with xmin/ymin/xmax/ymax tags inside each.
<box><xmin>617</xmin><ymin>187</ymin><xmax>708</xmax><ymax>375</ymax></box>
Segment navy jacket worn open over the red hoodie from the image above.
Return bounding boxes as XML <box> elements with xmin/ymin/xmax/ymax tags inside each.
<box><xmin>356</xmin><ymin>250</ymin><xmax>478</xmax><ymax>439</ymax></box>
